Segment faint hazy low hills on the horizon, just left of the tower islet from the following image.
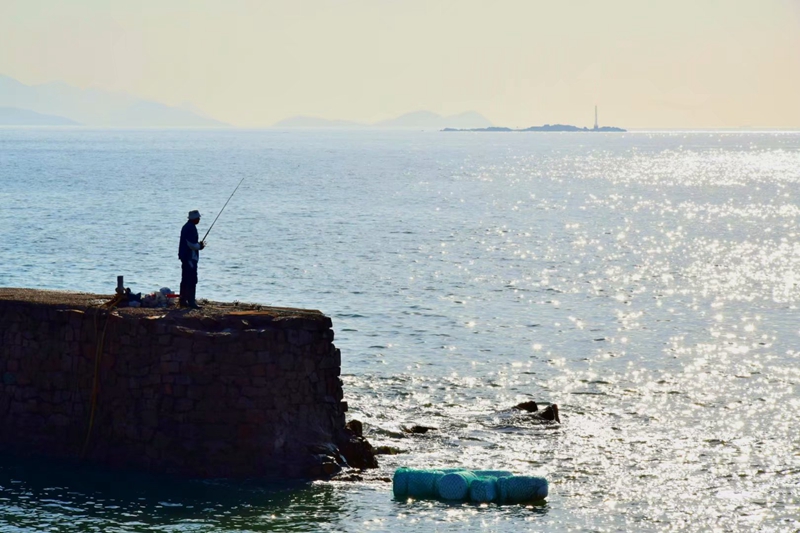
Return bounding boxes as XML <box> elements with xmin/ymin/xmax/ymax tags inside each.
<box><xmin>273</xmin><ymin>111</ymin><xmax>492</xmax><ymax>130</ymax></box>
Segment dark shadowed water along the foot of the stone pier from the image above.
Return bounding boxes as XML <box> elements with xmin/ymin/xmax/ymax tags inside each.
<box><xmin>0</xmin><ymin>457</ymin><xmax>347</xmax><ymax>531</ymax></box>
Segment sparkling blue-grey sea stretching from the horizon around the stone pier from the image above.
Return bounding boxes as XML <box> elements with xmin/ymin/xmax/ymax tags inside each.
<box><xmin>0</xmin><ymin>128</ymin><xmax>800</xmax><ymax>533</ymax></box>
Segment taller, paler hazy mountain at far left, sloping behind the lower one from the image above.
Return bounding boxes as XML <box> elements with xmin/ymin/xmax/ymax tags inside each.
<box><xmin>0</xmin><ymin>74</ymin><xmax>226</xmax><ymax>128</ymax></box>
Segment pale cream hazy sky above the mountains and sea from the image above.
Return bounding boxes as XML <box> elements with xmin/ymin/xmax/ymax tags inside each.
<box><xmin>0</xmin><ymin>0</ymin><xmax>800</xmax><ymax>128</ymax></box>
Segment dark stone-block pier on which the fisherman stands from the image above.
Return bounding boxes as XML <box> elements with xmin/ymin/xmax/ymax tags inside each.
<box><xmin>0</xmin><ymin>289</ymin><xmax>347</xmax><ymax>478</ymax></box>
